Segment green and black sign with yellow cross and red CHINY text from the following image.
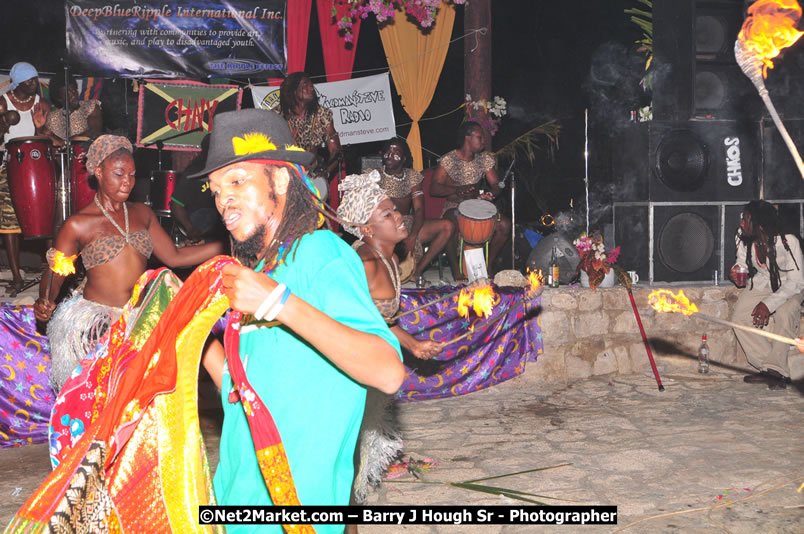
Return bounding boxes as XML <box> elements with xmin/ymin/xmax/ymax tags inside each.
<box><xmin>137</xmin><ymin>80</ymin><xmax>243</xmax><ymax>150</ymax></box>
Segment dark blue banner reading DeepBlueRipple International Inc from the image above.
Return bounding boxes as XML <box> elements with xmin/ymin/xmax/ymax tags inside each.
<box><xmin>65</xmin><ymin>0</ymin><xmax>287</xmax><ymax>79</ymax></box>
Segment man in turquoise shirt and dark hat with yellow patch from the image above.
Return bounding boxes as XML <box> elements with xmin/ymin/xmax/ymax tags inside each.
<box><xmin>192</xmin><ymin>109</ymin><xmax>404</xmax><ymax>532</ymax></box>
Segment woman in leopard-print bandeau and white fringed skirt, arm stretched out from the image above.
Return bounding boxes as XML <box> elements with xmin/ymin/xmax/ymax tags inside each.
<box><xmin>34</xmin><ymin>135</ymin><xmax>223</xmax><ymax>392</ymax></box>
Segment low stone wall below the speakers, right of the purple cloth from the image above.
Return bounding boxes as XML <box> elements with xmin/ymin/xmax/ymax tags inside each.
<box><xmin>523</xmin><ymin>286</ymin><xmax>750</xmax><ymax>384</ymax></box>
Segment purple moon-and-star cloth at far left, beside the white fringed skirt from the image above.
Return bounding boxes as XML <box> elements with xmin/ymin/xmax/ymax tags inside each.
<box><xmin>0</xmin><ymin>304</ymin><xmax>56</xmax><ymax>449</ymax></box>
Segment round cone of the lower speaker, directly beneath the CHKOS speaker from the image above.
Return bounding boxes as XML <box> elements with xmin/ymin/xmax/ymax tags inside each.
<box><xmin>657</xmin><ymin>212</ymin><xmax>715</xmax><ymax>274</ymax></box>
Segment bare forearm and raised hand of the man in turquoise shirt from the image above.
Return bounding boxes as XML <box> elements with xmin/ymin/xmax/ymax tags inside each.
<box><xmin>223</xmin><ymin>265</ymin><xmax>405</xmax><ymax>394</ymax></box>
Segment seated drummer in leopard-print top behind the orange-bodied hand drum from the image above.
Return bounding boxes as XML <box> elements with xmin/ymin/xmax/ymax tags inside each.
<box><xmin>430</xmin><ymin>121</ymin><xmax>511</xmax><ymax>282</ymax></box>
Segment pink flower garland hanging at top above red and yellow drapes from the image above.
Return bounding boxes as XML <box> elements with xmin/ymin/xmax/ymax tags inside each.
<box><xmin>332</xmin><ymin>0</ymin><xmax>466</xmax><ymax>43</ymax></box>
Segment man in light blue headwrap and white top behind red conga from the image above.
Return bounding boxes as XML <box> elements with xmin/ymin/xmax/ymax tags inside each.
<box><xmin>0</xmin><ymin>62</ymin><xmax>47</xmax><ymax>296</ymax></box>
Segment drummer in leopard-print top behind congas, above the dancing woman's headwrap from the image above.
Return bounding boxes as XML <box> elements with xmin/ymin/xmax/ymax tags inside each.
<box><xmin>43</xmin><ymin>76</ymin><xmax>103</xmax><ymax>146</ymax></box>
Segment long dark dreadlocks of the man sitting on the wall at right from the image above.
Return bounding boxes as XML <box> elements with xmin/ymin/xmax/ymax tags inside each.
<box><xmin>740</xmin><ymin>200</ymin><xmax>799</xmax><ymax>293</ymax></box>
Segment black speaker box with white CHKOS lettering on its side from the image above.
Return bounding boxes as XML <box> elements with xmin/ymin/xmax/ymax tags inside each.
<box><xmin>612</xmin><ymin>120</ymin><xmax>760</xmax><ymax>202</ymax></box>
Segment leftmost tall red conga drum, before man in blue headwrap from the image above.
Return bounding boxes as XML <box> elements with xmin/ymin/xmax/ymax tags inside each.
<box><xmin>6</xmin><ymin>137</ymin><xmax>56</xmax><ymax>238</ymax></box>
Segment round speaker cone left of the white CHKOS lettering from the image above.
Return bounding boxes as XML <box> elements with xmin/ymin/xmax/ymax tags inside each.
<box><xmin>655</xmin><ymin>130</ymin><xmax>709</xmax><ymax>193</ymax></box>
